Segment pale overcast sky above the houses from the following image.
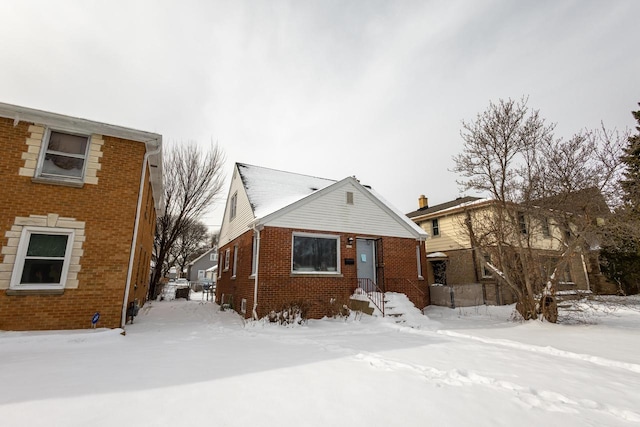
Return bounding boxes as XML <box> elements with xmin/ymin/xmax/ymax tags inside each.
<box><xmin>0</xmin><ymin>0</ymin><xmax>640</xmax><ymax>231</ymax></box>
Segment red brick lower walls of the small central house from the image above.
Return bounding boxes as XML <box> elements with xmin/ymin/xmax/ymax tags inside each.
<box><xmin>216</xmin><ymin>227</ymin><xmax>428</xmax><ymax>318</ymax></box>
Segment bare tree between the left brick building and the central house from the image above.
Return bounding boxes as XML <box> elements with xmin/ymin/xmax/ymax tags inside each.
<box><xmin>149</xmin><ymin>142</ymin><xmax>224</xmax><ymax>299</ymax></box>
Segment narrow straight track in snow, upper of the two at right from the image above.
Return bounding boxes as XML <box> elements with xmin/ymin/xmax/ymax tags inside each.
<box><xmin>436</xmin><ymin>330</ymin><xmax>640</xmax><ymax>374</ymax></box>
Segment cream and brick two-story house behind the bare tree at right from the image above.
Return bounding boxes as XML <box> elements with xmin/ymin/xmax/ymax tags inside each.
<box><xmin>407</xmin><ymin>196</ymin><xmax>590</xmax><ymax>306</ymax></box>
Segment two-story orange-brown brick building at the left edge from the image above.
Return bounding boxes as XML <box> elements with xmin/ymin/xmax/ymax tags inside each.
<box><xmin>0</xmin><ymin>103</ymin><xmax>163</xmax><ymax>330</ymax></box>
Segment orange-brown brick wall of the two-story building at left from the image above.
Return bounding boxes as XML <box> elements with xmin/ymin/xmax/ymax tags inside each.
<box><xmin>0</xmin><ymin>118</ymin><xmax>155</xmax><ymax>330</ymax></box>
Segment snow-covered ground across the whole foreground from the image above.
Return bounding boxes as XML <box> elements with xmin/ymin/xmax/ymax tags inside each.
<box><xmin>0</xmin><ymin>295</ymin><xmax>640</xmax><ymax>426</ymax></box>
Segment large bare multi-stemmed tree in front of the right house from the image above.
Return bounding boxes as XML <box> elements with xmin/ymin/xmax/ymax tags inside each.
<box><xmin>454</xmin><ymin>98</ymin><xmax>620</xmax><ymax>321</ymax></box>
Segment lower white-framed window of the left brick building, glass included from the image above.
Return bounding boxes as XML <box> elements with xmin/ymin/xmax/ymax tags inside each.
<box><xmin>10</xmin><ymin>227</ymin><xmax>74</xmax><ymax>290</ymax></box>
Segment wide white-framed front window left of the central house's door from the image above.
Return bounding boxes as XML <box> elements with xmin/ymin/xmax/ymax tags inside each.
<box><xmin>291</xmin><ymin>233</ymin><xmax>340</xmax><ymax>274</ymax></box>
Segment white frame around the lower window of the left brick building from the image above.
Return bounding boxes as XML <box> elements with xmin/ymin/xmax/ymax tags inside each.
<box><xmin>9</xmin><ymin>226</ymin><xmax>75</xmax><ymax>290</ymax></box>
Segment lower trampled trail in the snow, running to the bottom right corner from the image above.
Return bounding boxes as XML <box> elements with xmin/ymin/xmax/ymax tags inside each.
<box><xmin>353</xmin><ymin>353</ymin><xmax>640</xmax><ymax>422</ymax></box>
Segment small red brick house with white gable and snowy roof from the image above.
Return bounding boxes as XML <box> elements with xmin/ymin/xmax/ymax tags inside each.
<box><xmin>216</xmin><ymin>163</ymin><xmax>428</xmax><ymax>318</ymax></box>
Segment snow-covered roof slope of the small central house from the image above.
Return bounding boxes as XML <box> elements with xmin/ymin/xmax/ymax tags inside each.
<box><xmin>237</xmin><ymin>163</ymin><xmax>336</xmax><ymax>218</ymax></box>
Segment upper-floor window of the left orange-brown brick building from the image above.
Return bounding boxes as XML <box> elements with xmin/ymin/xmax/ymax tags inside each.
<box><xmin>37</xmin><ymin>129</ymin><xmax>89</xmax><ymax>181</ymax></box>
